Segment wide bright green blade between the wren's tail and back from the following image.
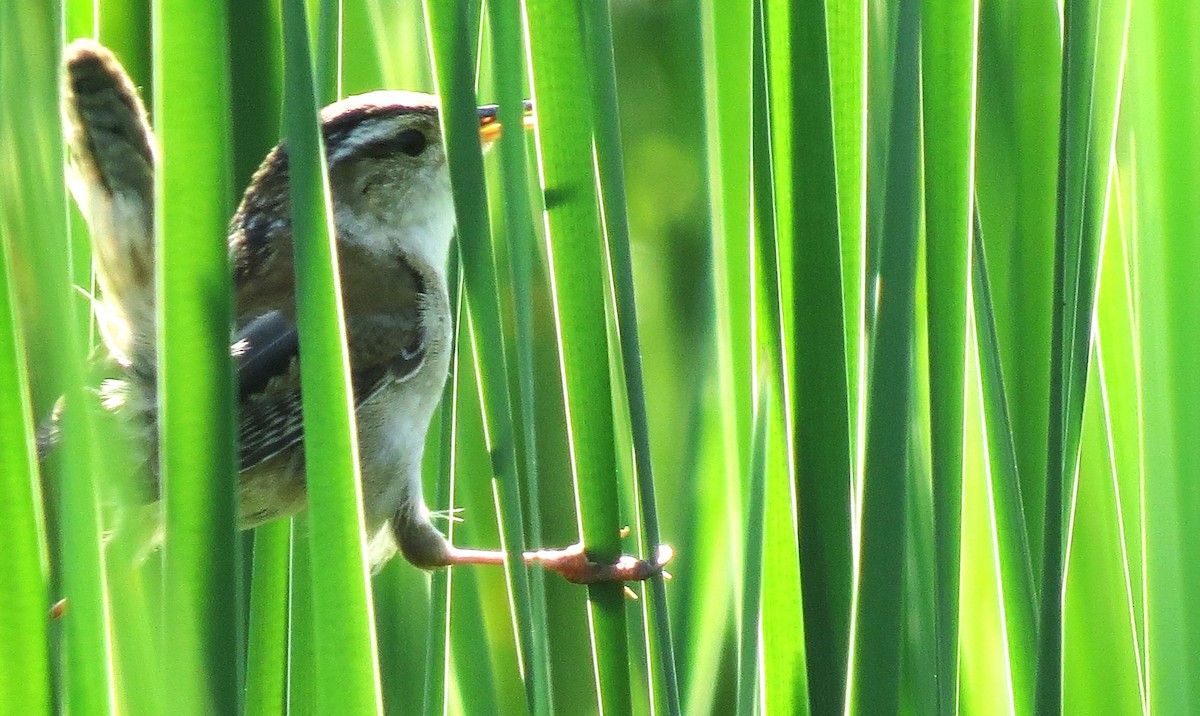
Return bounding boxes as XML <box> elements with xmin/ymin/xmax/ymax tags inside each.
<box><xmin>154</xmin><ymin>0</ymin><xmax>241</xmax><ymax>712</ymax></box>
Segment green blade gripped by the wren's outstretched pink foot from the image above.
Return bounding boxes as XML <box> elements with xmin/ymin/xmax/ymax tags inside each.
<box><xmin>526</xmin><ymin>0</ymin><xmax>631</xmax><ymax>714</ymax></box>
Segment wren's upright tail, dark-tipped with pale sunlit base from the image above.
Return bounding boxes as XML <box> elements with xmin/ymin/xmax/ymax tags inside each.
<box><xmin>62</xmin><ymin>40</ymin><xmax>156</xmax><ymax>366</ymax></box>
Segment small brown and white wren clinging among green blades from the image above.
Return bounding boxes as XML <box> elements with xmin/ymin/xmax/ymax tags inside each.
<box><xmin>64</xmin><ymin>40</ymin><xmax>665</xmax><ymax>583</ymax></box>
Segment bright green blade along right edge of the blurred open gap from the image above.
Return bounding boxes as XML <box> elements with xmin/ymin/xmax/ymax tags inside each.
<box><xmin>686</xmin><ymin>0</ymin><xmax>754</xmax><ymax>714</ymax></box>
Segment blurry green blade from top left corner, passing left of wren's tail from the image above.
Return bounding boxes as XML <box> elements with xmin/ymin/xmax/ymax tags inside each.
<box><xmin>0</xmin><ymin>8</ymin><xmax>116</xmax><ymax>714</ymax></box>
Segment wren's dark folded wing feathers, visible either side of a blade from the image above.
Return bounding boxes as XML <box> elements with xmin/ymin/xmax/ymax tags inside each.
<box><xmin>233</xmin><ymin>302</ymin><xmax>426</xmax><ymax>470</ymax></box>
